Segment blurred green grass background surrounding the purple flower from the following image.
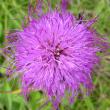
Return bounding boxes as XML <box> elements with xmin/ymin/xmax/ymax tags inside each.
<box><xmin>0</xmin><ymin>0</ymin><xmax>110</xmax><ymax>110</ymax></box>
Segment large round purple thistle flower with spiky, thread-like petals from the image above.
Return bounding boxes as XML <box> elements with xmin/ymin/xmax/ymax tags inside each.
<box><xmin>4</xmin><ymin>0</ymin><xmax>107</xmax><ymax>107</ymax></box>
